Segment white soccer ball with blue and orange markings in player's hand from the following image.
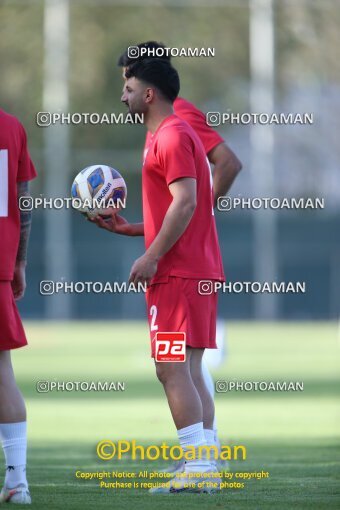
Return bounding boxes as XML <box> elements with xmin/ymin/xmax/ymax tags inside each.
<box><xmin>71</xmin><ymin>165</ymin><xmax>127</xmax><ymax>217</ymax></box>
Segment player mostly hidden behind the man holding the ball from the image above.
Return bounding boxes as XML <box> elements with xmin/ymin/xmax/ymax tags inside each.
<box><xmin>118</xmin><ymin>41</ymin><xmax>242</xmax><ymax>472</ymax></box>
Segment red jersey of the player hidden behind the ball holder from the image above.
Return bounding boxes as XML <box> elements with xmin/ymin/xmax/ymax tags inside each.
<box><xmin>144</xmin><ymin>97</ymin><xmax>224</xmax><ymax>158</ymax></box>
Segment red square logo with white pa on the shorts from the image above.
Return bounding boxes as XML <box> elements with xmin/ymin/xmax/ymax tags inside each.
<box><xmin>154</xmin><ymin>331</ymin><xmax>186</xmax><ymax>363</ymax></box>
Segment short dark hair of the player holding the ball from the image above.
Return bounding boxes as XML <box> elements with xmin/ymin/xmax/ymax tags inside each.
<box><xmin>125</xmin><ymin>58</ymin><xmax>180</xmax><ymax>103</ymax></box>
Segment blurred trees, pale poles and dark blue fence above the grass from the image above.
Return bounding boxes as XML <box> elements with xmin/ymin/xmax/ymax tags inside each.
<box><xmin>0</xmin><ymin>0</ymin><xmax>340</xmax><ymax>320</ymax></box>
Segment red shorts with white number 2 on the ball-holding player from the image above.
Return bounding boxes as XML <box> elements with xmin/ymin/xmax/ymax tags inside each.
<box><xmin>146</xmin><ymin>276</ymin><xmax>217</xmax><ymax>357</ymax></box>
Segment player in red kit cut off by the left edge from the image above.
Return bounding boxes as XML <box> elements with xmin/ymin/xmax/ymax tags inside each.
<box><xmin>0</xmin><ymin>110</ymin><xmax>36</xmax><ymax>504</ymax></box>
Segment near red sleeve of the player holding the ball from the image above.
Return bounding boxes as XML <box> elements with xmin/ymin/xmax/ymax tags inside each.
<box><xmin>157</xmin><ymin>128</ymin><xmax>197</xmax><ymax>186</ymax></box>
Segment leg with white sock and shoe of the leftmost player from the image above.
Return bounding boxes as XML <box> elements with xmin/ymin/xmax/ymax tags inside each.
<box><xmin>0</xmin><ymin>351</ymin><xmax>31</xmax><ymax>504</ymax></box>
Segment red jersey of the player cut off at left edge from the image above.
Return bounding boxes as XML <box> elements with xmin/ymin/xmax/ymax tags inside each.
<box><xmin>0</xmin><ymin>110</ymin><xmax>36</xmax><ymax>280</ymax></box>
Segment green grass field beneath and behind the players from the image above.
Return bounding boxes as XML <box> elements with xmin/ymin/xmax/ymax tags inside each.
<box><xmin>4</xmin><ymin>322</ymin><xmax>340</xmax><ymax>510</ymax></box>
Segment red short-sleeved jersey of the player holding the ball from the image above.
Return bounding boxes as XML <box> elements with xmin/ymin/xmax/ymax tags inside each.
<box><xmin>142</xmin><ymin>115</ymin><xmax>224</xmax><ymax>283</ymax></box>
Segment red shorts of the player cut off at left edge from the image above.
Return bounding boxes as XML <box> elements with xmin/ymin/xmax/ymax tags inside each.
<box><xmin>0</xmin><ymin>281</ymin><xmax>27</xmax><ymax>351</ymax></box>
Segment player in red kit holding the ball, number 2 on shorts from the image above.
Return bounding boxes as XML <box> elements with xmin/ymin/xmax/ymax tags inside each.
<box><xmin>91</xmin><ymin>59</ymin><xmax>224</xmax><ymax>492</ymax></box>
